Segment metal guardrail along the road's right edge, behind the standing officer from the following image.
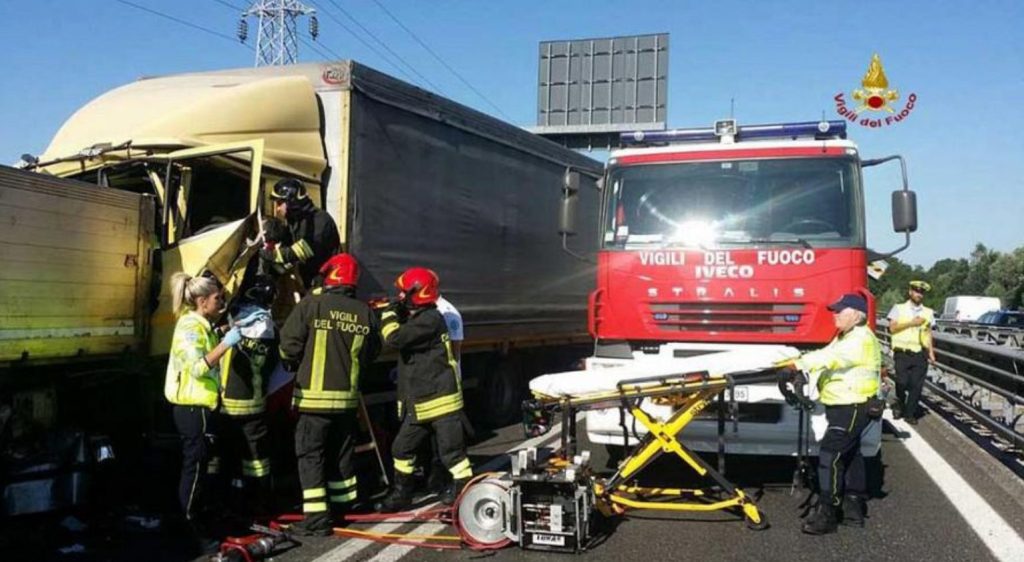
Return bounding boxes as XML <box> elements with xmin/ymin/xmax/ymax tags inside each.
<box><xmin>876</xmin><ymin>318</ymin><xmax>1024</xmax><ymax>455</ymax></box>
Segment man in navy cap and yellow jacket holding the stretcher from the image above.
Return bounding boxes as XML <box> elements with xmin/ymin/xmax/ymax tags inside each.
<box><xmin>779</xmin><ymin>294</ymin><xmax>882</xmax><ymax>534</ymax></box>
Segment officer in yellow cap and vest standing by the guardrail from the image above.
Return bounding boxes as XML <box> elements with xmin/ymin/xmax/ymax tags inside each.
<box><xmin>888</xmin><ymin>280</ymin><xmax>935</xmax><ymax>425</ymax></box>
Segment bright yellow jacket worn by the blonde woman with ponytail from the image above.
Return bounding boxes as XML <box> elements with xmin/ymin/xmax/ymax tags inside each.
<box><xmin>164</xmin><ymin>310</ymin><xmax>220</xmax><ymax>409</ymax></box>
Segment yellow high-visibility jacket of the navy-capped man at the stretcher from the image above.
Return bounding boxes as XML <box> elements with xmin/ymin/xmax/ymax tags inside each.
<box><xmin>797</xmin><ymin>326</ymin><xmax>882</xmax><ymax>405</ymax></box>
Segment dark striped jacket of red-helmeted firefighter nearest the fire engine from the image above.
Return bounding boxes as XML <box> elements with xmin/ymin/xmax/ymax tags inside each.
<box><xmin>381</xmin><ymin>308</ymin><xmax>463</xmax><ymax>422</ymax></box>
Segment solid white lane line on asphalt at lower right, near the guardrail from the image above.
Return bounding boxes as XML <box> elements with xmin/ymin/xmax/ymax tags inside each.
<box><xmin>889</xmin><ymin>421</ymin><xmax>1024</xmax><ymax>561</ymax></box>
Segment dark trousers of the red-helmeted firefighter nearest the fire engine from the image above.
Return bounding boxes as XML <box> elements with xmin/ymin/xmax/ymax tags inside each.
<box><xmin>391</xmin><ymin>413</ymin><xmax>473</xmax><ymax>480</ymax></box>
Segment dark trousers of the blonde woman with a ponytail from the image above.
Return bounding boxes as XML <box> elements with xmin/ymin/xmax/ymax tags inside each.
<box><xmin>173</xmin><ymin>405</ymin><xmax>219</xmax><ymax>525</ymax></box>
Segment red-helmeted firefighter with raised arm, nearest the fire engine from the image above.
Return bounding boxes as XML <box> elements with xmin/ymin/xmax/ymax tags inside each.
<box><xmin>377</xmin><ymin>267</ymin><xmax>473</xmax><ymax>512</ymax></box>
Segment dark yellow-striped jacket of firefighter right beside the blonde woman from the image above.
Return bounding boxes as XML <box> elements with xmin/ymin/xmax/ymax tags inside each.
<box><xmin>220</xmin><ymin>337</ymin><xmax>279</xmax><ymax>416</ymax></box>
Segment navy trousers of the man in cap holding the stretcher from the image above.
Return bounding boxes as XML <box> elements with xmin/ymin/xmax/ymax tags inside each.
<box><xmin>818</xmin><ymin>402</ymin><xmax>870</xmax><ymax>506</ymax></box>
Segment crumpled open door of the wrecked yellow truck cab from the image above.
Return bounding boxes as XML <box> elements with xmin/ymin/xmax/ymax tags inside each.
<box><xmin>150</xmin><ymin>139</ymin><xmax>263</xmax><ymax>354</ymax></box>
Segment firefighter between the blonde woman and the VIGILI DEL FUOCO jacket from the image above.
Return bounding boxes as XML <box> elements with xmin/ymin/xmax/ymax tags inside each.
<box><xmin>220</xmin><ymin>275</ymin><xmax>279</xmax><ymax>513</ymax></box>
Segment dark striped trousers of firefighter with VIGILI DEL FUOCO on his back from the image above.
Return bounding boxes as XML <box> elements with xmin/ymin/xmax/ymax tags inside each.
<box><xmin>295</xmin><ymin>409</ymin><xmax>358</xmax><ymax>514</ymax></box>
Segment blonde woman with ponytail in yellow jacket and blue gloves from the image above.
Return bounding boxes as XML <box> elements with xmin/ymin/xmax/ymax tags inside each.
<box><xmin>164</xmin><ymin>272</ymin><xmax>244</xmax><ymax>552</ymax></box>
